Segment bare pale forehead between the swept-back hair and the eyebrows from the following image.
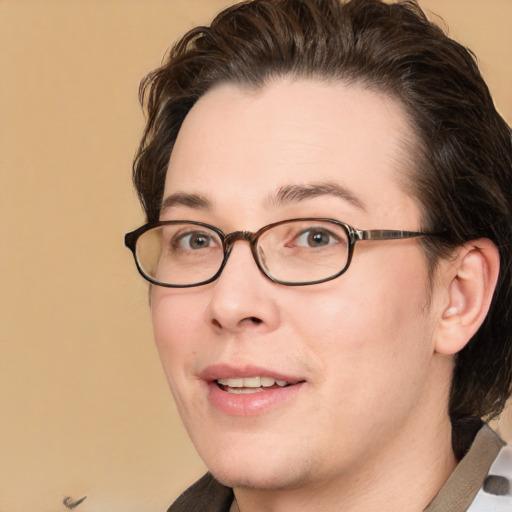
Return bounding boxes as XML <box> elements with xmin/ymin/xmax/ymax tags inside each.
<box><xmin>164</xmin><ymin>78</ymin><xmax>420</xmax><ymax>225</ymax></box>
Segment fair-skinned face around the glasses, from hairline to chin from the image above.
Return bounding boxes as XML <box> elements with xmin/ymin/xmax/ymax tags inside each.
<box><xmin>152</xmin><ymin>79</ymin><xmax>444</xmax><ymax>489</ymax></box>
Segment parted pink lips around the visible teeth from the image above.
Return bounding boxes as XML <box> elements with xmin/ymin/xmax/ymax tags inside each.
<box><xmin>200</xmin><ymin>365</ymin><xmax>306</xmax><ymax>417</ymax></box>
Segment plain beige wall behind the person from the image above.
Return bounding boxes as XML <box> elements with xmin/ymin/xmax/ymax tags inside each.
<box><xmin>0</xmin><ymin>0</ymin><xmax>512</xmax><ymax>512</ymax></box>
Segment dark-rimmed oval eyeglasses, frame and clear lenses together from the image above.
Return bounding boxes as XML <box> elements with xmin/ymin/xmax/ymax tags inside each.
<box><xmin>125</xmin><ymin>218</ymin><xmax>439</xmax><ymax>288</ymax></box>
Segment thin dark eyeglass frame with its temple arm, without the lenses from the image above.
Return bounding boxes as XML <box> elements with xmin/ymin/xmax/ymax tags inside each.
<box><xmin>124</xmin><ymin>217</ymin><xmax>443</xmax><ymax>288</ymax></box>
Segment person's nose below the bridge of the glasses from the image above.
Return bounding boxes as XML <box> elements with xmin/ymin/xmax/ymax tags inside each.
<box><xmin>205</xmin><ymin>239</ymin><xmax>279</xmax><ymax>334</ymax></box>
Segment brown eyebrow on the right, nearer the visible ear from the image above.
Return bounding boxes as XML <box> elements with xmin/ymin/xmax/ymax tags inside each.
<box><xmin>269</xmin><ymin>182</ymin><xmax>366</xmax><ymax>211</ymax></box>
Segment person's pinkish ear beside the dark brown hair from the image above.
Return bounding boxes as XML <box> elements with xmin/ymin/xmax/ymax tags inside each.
<box><xmin>435</xmin><ymin>238</ymin><xmax>500</xmax><ymax>355</ymax></box>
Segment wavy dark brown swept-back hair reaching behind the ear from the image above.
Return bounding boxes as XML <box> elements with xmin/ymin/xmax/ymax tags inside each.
<box><xmin>134</xmin><ymin>0</ymin><xmax>512</xmax><ymax>455</ymax></box>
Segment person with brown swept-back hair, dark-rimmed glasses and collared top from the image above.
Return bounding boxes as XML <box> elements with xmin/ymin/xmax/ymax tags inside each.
<box><xmin>126</xmin><ymin>0</ymin><xmax>512</xmax><ymax>512</ymax></box>
